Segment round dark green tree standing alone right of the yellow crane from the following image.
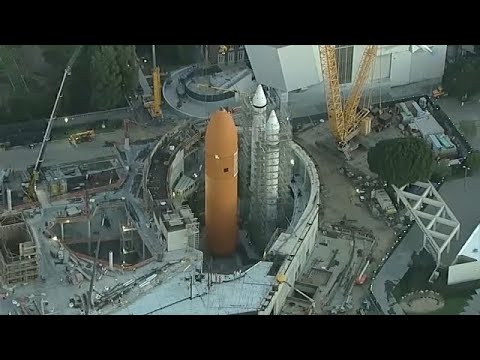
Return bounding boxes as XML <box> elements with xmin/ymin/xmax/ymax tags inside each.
<box><xmin>367</xmin><ymin>137</ymin><xmax>433</xmax><ymax>186</ymax></box>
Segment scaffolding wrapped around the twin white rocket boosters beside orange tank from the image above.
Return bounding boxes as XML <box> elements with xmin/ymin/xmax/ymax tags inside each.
<box><xmin>235</xmin><ymin>89</ymin><xmax>292</xmax><ymax>246</ymax></box>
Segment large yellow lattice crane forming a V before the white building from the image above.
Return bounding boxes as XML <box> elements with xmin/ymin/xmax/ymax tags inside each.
<box><xmin>319</xmin><ymin>45</ymin><xmax>378</xmax><ymax>158</ymax></box>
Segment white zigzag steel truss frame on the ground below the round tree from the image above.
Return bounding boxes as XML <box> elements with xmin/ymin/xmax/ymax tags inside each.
<box><xmin>393</xmin><ymin>181</ymin><xmax>460</xmax><ymax>269</ymax></box>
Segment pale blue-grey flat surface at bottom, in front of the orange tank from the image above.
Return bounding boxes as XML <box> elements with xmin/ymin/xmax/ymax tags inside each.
<box><xmin>114</xmin><ymin>262</ymin><xmax>275</xmax><ymax>315</ymax></box>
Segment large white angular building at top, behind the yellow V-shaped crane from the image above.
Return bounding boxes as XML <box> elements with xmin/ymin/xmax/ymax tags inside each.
<box><xmin>245</xmin><ymin>45</ymin><xmax>447</xmax><ymax>113</ymax></box>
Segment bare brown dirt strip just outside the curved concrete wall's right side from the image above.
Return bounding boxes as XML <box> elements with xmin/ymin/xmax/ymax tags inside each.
<box><xmin>296</xmin><ymin>128</ymin><xmax>395</xmax><ymax>310</ymax></box>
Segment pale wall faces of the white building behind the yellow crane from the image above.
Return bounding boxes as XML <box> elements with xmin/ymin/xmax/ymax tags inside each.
<box><xmin>246</xmin><ymin>45</ymin><xmax>447</xmax><ymax>91</ymax></box>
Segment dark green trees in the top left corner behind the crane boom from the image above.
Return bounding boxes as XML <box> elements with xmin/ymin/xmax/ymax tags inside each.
<box><xmin>0</xmin><ymin>45</ymin><xmax>138</xmax><ymax>122</ymax></box>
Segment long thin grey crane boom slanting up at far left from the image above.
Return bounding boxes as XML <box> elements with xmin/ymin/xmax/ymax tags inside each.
<box><xmin>26</xmin><ymin>45</ymin><xmax>83</xmax><ymax>201</ymax></box>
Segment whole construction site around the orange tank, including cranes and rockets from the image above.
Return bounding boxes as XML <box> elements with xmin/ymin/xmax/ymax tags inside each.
<box><xmin>0</xmin><ymin>45</ymin><xmax>478</xmax><ymax>315</ymax></box>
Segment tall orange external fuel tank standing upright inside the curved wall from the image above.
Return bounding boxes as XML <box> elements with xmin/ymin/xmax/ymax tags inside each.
<box><xmin>205</xmin><ymin>110</ymin><xmax>238</xmax><ymax>256</ymax></box>
